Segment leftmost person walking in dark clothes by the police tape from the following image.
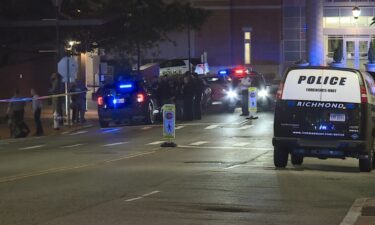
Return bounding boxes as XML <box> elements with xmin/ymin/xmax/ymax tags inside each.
<box><xmin>7</xmin><ymin>89</ymin><xmax>30</xmax><ymax>138</ymax></box>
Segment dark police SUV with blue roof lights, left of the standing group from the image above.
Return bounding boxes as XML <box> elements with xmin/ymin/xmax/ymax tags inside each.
<box><xmin>96</xmin><ymin>79</ymin><xmax>160</xmax><ymax>127</ymax></box>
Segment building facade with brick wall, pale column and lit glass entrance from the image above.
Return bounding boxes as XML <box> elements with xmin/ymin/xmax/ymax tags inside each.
<box><xmin>150</xmin><ymin>0</ymin><xmax>375</xmax><ymax>74</ymax></box>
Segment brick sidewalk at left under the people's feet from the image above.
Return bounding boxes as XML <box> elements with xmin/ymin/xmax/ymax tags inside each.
<box><xmin>0</xmin><ymin>106</ymin><xmax>98</xmax><ymax>140</ymax></box>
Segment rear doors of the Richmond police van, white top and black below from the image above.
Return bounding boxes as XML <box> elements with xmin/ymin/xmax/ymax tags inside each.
<box><xmin>275</xmin><ymin>69</ymin><xmax>362</xmax><ymax>140</ymax></box>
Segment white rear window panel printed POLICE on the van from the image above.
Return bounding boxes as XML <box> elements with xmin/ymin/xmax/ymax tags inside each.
<box><xmin>282</xmin><ymin>69</ymin><xmax>361</xmax><ymax>103</ymax></box>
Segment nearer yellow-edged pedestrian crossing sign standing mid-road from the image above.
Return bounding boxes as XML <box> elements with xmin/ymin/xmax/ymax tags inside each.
<box><xmin>161</xmin><ymin>104</ymin><xmax>177</xmax><ymax>147</ymax></box>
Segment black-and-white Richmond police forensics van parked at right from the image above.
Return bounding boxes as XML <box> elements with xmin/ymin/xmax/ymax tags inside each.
<box><xmin>272</xmin><ymin>67</ymin><xmax>375</xmax><ymax>172</ymax></box>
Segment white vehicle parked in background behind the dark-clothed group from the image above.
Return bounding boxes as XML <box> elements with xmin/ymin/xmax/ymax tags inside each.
<box><xmin>159</xmin><ymin>58</ymin><xmax>210</xmax><ymax>76</ymax></box>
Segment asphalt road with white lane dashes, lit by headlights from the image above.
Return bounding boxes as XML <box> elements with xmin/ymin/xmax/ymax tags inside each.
<box><xmin>0</xmin><ymin>109</ymin><xmax>375</xmax><ymax>225</ymax></box>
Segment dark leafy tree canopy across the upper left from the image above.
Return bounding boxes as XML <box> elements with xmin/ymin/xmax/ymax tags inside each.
<box><xmin>0</xmin><ymin>0</ymin><xmax>209</xmax><ymax>67</ymax></box>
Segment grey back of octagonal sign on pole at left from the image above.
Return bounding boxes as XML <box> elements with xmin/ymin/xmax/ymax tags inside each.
<box><xmin>57</xmin><ymin>56</ymin><xmax>78</xmax><ymax>83</ymax></box>
